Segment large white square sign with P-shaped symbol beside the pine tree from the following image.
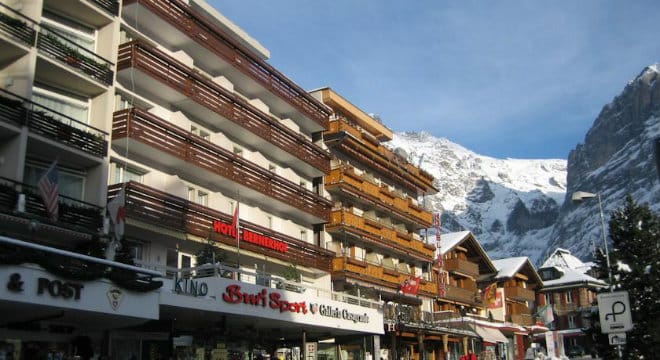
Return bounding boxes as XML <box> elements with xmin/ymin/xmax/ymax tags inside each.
<box><xmin>598</xmin><ymin>291</ymin><xmax>632</xmax><ymax>334</ymax></box>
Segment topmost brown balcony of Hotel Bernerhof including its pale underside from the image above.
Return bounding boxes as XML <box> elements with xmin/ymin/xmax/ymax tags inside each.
<box><xmin>122</xmin><ymin>0</ymin><xmax>330</xmax><ymax>131</ymax></box>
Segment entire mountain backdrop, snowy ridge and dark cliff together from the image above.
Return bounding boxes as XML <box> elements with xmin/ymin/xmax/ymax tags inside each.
<box><xmin>388</xmin><ymin>64</ymin><xmax>660</xmax><ymax>264</ymax></box>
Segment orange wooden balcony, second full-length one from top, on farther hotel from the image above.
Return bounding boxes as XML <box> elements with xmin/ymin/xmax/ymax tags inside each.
<box><xmin>325</xmin><ymin>166</ymin><xmax>433</xmax><ymax>228</ymax></box>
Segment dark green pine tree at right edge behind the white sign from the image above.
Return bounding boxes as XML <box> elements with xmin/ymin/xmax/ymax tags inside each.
<box><xmin>599</xmin><ymin>195</ymin><xmax>660</xmax><ymax>359</ymax></box>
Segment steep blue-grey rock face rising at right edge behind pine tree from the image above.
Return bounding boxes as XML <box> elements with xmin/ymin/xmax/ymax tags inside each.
<box><xmin>545</xmin><ymin>64</ymin><xmax>660</xmax><ymax>259</ymax></box>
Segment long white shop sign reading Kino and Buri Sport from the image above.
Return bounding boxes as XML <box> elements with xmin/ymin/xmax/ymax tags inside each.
<box><xmin>161</xmin><ymin>277</ymin><xmax>384</xmax><ymax>334</ymax></box>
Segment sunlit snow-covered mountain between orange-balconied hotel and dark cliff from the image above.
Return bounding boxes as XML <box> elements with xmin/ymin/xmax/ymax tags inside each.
<box><xmin>388</xmin><ymin>132</ymin><xmax>566</xmax><ymax>261</ymax></box>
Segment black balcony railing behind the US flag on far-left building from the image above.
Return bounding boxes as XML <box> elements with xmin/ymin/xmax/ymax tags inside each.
<box><xmin>0</xmin><ymin>177</ymin><xmax>103</xmax><ymax>236</ymax></box>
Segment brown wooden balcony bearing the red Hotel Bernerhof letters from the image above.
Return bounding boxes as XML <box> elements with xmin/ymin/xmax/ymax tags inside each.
<box><xmin>108</xmin><ymin>182</ymin><xmax>334</xmax><ymax>272</ymax></box>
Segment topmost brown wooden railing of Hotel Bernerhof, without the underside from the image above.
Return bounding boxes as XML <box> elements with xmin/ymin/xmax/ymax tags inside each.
<box><xmin>124</xmin><ymin>0</ymin><xmax>330</xmax><ymax>128</ymax></box>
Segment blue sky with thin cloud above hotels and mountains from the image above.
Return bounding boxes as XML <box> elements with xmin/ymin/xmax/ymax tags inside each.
<box><xmin>213</xmin><ymin>0</ymin><xmax>660</xmax><ymax>159</ymax></box>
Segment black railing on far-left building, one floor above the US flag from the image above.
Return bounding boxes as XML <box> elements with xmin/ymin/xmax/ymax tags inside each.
<box><xmin>0</xmin><ymin>89</ymin><xmax>108</xmax><ymax>157</ymax></box>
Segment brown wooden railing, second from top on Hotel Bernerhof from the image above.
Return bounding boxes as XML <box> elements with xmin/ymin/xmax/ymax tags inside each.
<box><xmin>118</xmin><ymin>41</ymin><xmax>330</xmax><ymax>173</ymax></box>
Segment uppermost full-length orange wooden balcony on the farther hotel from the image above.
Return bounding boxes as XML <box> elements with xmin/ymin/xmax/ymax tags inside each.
<box><xmin>324</xmin><ymin>119</ymin><xmax>437</xmax><ymax>193</ymax></box>
